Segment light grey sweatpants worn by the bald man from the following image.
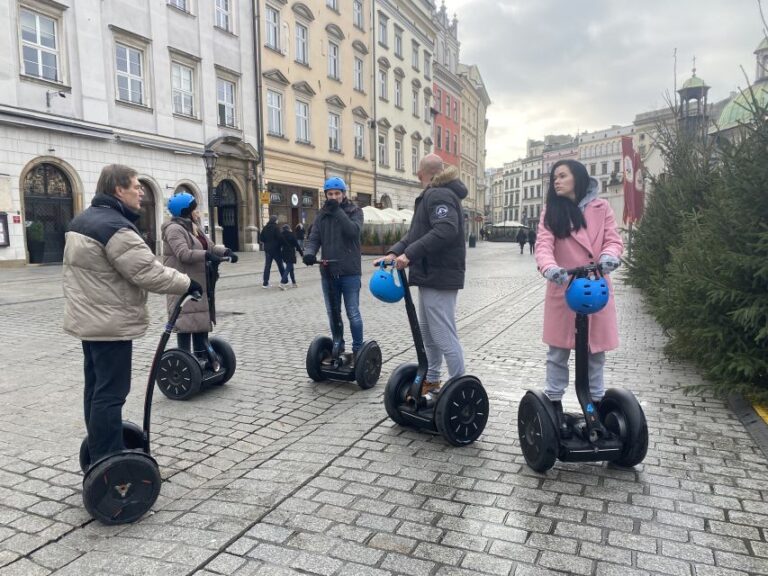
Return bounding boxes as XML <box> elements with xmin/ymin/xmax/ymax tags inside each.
<box><xmin>419</xmin><ymin>287</ymin><xmax>464</xmax><ymax>382</ymax></box>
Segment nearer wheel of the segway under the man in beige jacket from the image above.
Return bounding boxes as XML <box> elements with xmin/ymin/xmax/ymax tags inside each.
<box><xmin>83</xmin><ymin>452</ymin><xmax>162</xmax><ymax>525</ymax></box>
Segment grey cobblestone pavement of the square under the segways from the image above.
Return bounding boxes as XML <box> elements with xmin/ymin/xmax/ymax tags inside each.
<box><xmin>0</xmin><ymin>243</ymin><xmax>768</xmax><ymax>576</ymax></box>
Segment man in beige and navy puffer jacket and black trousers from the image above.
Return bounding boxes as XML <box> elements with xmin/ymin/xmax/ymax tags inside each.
<box><xmin>63</xmin><ymin>164</ymin><xmax>200</xmax><ymax>463</ymax></box>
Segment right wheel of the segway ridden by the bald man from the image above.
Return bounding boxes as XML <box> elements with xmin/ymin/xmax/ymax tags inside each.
<box><xmin>435</xmin><ymin>376</ymin><xmax>489</xmax><ymax>446</ymax></box>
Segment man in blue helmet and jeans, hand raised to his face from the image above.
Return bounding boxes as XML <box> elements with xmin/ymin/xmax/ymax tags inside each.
<box><xmin>303</xmin><ymin>177</ymin><xmax>363</xmax><ymax>362</ymax></box>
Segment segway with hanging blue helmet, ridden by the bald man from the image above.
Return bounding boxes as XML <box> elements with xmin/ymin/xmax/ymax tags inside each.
<box><xmin>371</xmin><ymin>260</ymin><xmax>489</xmax><ymax>446</ymax></box>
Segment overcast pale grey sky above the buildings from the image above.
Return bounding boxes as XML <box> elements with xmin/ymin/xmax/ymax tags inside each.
<box><xmin>435</xmin><ymin>0</ymin><xmax>768</xmax><ymax>167</ymax></box>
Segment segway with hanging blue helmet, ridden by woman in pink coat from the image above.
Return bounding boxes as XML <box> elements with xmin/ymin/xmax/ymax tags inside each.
<box><xmin>517</xmin><ymin>264</ymin><xmax>648</xmax><ymax>472</ymax></box>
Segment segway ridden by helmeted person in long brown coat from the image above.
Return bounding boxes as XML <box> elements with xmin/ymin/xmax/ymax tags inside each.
<box><xmin>157</xmin><ymin>257</ymin><xmax>237</xmax><ymax>400</ymax></box>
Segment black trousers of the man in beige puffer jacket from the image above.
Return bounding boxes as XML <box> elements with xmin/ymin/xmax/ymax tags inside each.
<box><xmin>83</xmin><ymin>340</ymin><xmax>133</xmax><ymax>462</ymax></box>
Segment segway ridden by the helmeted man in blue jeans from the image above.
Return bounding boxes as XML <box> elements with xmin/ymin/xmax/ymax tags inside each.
<box><xmin>306</xmin><ymin>260</ymin><xmax>381</xmax><ymax>390</ymax></box>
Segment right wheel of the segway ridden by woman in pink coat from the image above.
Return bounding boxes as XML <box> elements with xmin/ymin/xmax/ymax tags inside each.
<box><xmin>597</xmin><ymin>388</ymin><xmax>648</xmax><ymax>468</ymax></box>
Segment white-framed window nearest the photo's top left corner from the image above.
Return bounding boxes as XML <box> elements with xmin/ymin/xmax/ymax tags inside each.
<box><xmin>19</xmin><ymin>8</ymin><xmax>61</xmax><ymax>82</ymax></box>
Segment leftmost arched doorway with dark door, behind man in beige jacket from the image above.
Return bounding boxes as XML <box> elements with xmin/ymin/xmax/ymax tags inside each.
<box><xmin>23</xmin><ymin>163</ymin><xmax>74</xmax><ymax>264</ymax></box>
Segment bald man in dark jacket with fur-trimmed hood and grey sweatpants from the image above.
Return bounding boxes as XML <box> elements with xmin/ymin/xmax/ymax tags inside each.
<box><xmin>374</xmin><ymin>154</ymin><xmax>467</xmax><ymax>396</ymax></box>
